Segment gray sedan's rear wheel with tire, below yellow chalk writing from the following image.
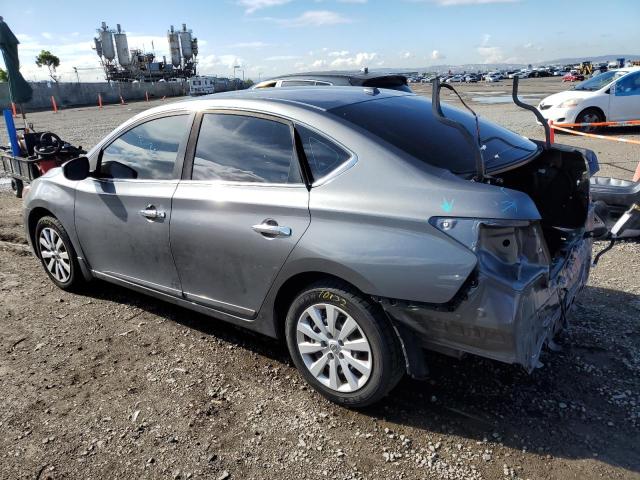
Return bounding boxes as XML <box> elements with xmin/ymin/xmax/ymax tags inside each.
<box><xmin>285</xmin><ymin>282</ymin><xmax>405</xmax><ymax>408</ymax></box>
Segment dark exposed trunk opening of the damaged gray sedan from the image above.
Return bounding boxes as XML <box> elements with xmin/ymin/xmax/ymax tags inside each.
<box><xmin>495</xmin><ymin>146</ymin><xmax>589</xmax><ymax>260</ymax></box>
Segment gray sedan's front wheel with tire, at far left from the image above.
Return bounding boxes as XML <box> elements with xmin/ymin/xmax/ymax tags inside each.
<box><xmin>34</xmin><ymin>216</ymin><xmax>84</xmax><ymax>291</ymax></box>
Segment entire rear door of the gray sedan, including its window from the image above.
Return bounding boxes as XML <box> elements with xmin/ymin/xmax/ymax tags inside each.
<box><xmin>171</xmin><ymin>111</ymin><xmax>310</xmax><ymax>318</ymax></box>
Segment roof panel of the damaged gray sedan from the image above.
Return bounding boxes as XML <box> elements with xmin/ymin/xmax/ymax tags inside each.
<box><xmin>140</xmin><ymin>87</ymin><xmax>415</xmax><ymax>116</ymax></box>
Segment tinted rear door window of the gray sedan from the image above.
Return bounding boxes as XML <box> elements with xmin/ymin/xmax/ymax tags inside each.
<box><xmin>192</xmin><ymin>113</ymin><xmax>301</xmax><ymax>183</ymax></box>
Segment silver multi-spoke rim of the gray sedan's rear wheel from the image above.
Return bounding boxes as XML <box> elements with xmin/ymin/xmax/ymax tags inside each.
<box><xmin>296</xmin><ymin>303</ymin><xmax>373</xmax><ymax>393</ymax></box>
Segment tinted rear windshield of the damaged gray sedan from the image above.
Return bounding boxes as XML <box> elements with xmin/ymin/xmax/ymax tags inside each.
<box><xmin>329</xmin><ymin>95</ymin><xmax>538</xmax><ymax>174</ymax></box>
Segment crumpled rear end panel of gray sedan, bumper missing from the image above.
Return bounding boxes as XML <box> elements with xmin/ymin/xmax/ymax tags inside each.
<box><xmin>382</xmin><ymin>232</ymin><xmax>592</xmax><ymax>371</ymax></box>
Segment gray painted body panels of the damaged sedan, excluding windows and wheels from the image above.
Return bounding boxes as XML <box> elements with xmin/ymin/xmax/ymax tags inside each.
<box><xmin>25</xmin><ymin>87</ymin><xmax>591</xmax><ymax>369</ymax></box>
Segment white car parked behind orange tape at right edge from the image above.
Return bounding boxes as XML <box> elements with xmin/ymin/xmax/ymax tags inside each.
<box><xmin>538</xmin><ymin>67</ymin><xmax>640</xmax><ymax>123</ymax></box>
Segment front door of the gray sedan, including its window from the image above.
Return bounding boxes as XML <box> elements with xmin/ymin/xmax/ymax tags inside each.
<box><xmin>75</xmin><ymin>114</ymin><xmax>192</xmax><ymax>295</ymax></box>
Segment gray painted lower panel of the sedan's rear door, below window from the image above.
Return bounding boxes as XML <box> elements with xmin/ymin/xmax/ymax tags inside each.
<box><xmin>171</xmin><ymin>182</ymin><xmax>310</xmax><ymax>317</ymax></box>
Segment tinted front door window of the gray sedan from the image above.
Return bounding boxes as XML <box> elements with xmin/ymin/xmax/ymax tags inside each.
<box><xmin>100</xmin><ymin>115</ymin><xmax>189</xmax><ymax>180</ymax></box>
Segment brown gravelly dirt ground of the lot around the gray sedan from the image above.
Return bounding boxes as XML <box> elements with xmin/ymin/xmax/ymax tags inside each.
<box><xmin>0</xmin><ymin>79</ymin><xmax>640</xmax><ymax>480</ymax></box>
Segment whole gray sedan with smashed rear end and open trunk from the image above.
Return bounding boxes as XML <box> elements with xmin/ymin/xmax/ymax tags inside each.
<box><xmin>24</xmin><ymin>87</ymin><xmax>594</xmax><ymax>407</ymax></box>
